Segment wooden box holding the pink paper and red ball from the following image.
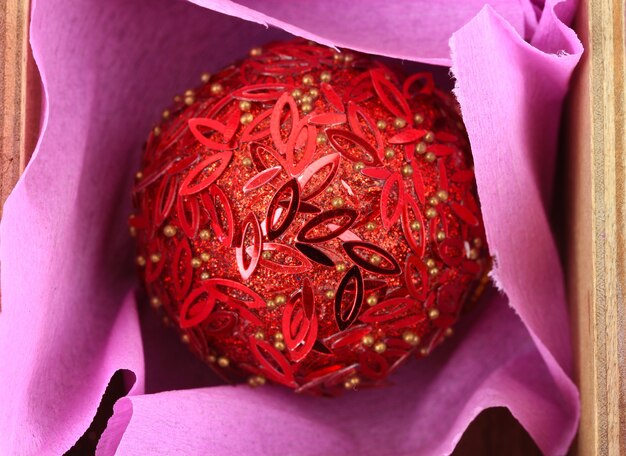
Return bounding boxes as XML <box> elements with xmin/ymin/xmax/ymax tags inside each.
<box><xmin>0</xmin><ymin>0</ymin><xmax>626</xmax><ymax>456</ymax></box>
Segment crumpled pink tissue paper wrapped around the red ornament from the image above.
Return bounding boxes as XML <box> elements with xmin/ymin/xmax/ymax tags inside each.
<box><xmin>0</xmin><ymin>0</ymin><xmax>582</xmax><ymax>456</ymax></box>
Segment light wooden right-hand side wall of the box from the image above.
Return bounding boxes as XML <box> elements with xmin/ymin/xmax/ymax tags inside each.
<box><xmin>564</xmin><ymin>0</ymin><xmax>626</xmax><ymax>456</ymax></box>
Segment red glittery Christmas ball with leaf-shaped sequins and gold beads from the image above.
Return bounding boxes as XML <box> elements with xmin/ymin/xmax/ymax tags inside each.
<box><xmin>130</xmin><ymin>40</ymin><xmax>489</xmax><ymax>395</ymax></box>
